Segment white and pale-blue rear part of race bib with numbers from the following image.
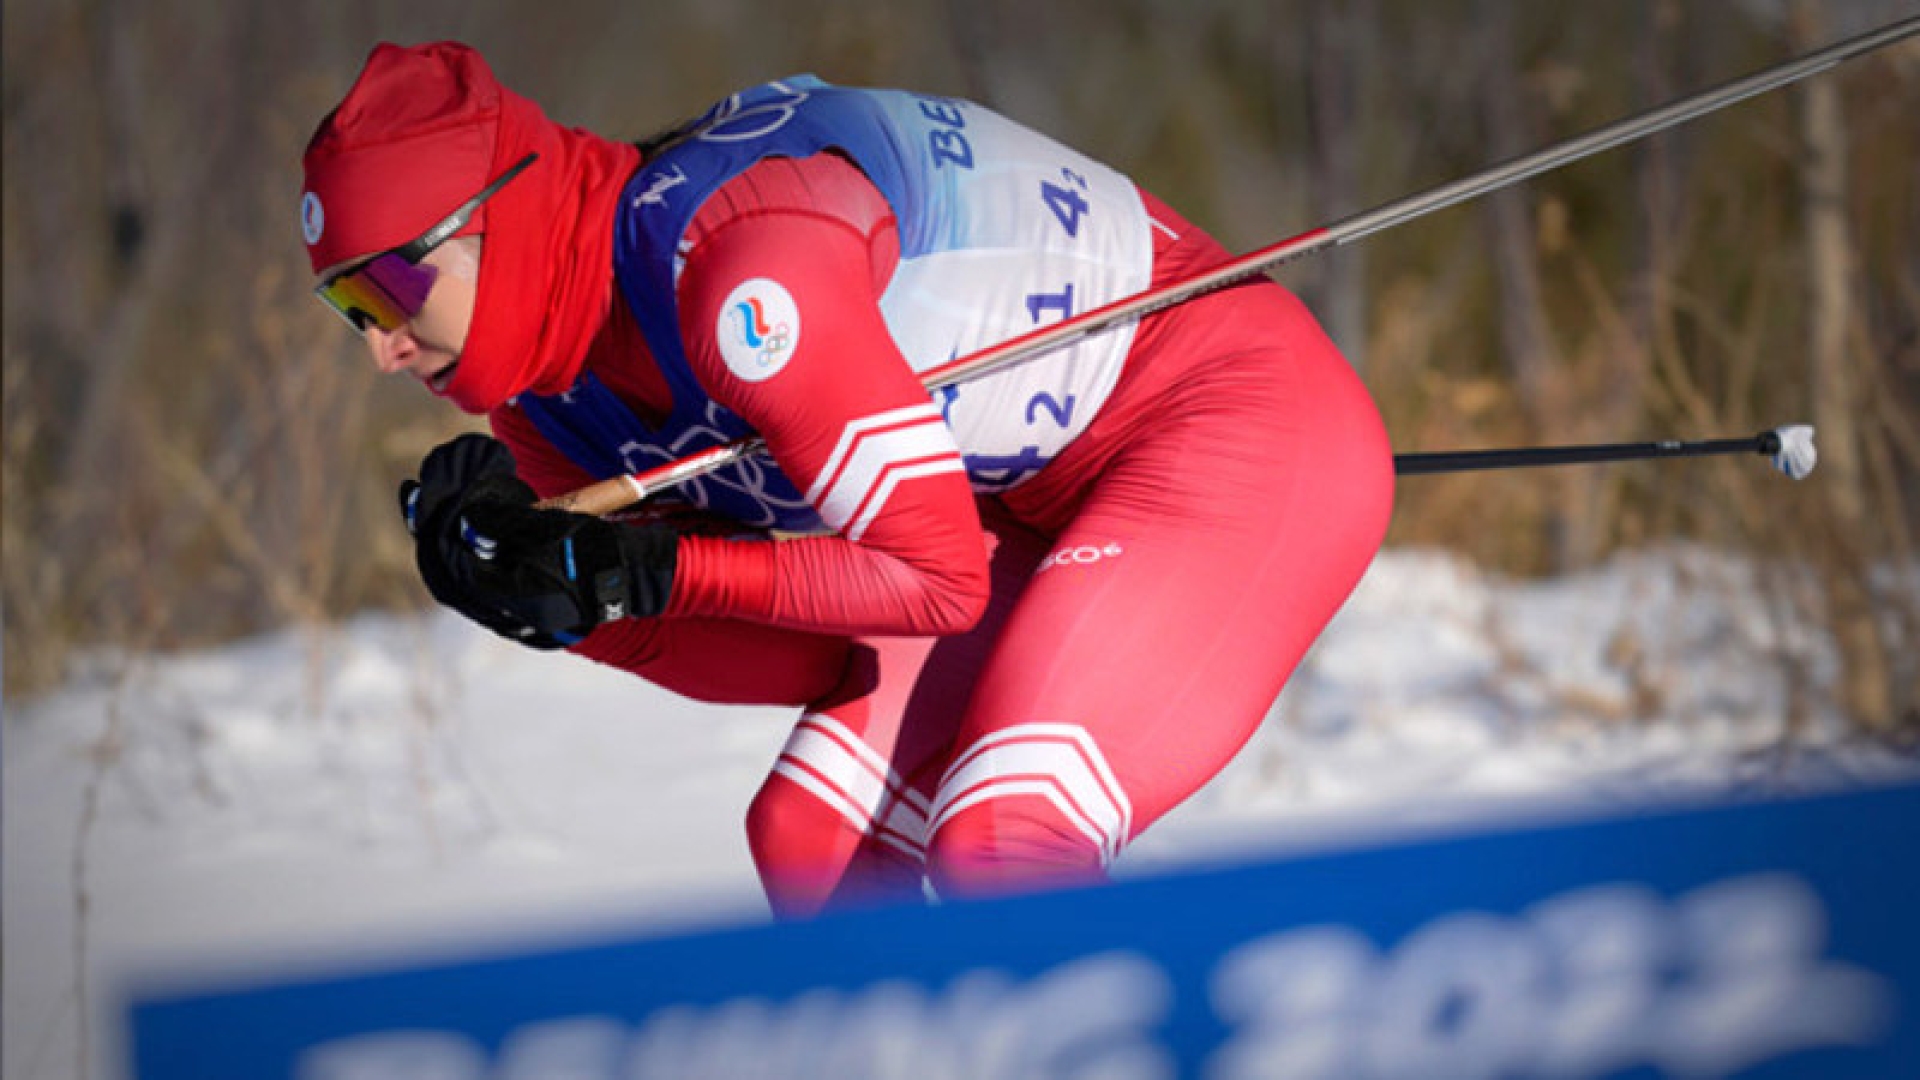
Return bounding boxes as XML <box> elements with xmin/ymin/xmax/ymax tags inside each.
<box><xmin>881</xmin><ymin>94</ymin><xmax>1154</xmax><ymax>492</ymax></box>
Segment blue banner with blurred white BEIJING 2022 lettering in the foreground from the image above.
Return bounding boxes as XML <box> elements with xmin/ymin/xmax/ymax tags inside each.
<box><xmin>129</xmin><ymin>786</ymin><xmax>1920</xmax><ymax>1080</ymax></box>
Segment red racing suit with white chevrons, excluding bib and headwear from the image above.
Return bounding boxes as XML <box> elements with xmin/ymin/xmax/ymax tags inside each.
<box><xmin>492</xmin><ymin>119</ymin><xmax>1392</xmax><ymax>917</ymax></box>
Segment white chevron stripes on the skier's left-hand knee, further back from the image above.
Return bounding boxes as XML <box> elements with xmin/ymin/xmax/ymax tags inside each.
<box><xmin>774</xmin><ymin>713</ymin><xmax>927</xmax><ymax>859</ymax></box>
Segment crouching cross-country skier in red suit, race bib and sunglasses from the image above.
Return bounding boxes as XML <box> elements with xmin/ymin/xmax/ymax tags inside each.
<box><xmin>301</xmin><ymin>42</ymin><xmax>1392</xmax><ymax>917</ymax></box>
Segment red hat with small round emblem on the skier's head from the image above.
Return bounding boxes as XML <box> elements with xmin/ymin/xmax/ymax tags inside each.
<box><xmin>300</xmin><ymin>42</ymin><xmax>501</xmax><ymax>271</ymax></box>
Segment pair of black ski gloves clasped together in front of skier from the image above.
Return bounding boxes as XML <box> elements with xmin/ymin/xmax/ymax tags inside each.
<box><xmin>399</xmin><ymin>434</ymin><xmax>680</xmax><ymax>650</ymax></box>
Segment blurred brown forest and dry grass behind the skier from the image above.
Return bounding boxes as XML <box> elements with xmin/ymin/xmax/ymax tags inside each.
<box><xmin>4</xmin><ymin>0</ymin><xmax>1920</xmax><ymax>722</ymax></box>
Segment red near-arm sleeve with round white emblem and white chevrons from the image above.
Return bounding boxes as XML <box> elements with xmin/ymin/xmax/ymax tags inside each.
<box><xmin>668</xmin><ymin>156</ymin><xmax>987</xmax><ymax>634</ymax></box>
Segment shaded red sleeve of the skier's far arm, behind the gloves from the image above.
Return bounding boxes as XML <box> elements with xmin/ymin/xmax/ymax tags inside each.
<box><xmin>490</xmin><ymin>405</ymin><xmax>851</xmax><ymax>705</ymax></box>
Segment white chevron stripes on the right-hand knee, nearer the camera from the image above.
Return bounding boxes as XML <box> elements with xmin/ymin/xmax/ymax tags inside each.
<box><xmin>927</xmin><ymin>724</ymin><xmax>1133</xmax><ymax>865</ymax></box>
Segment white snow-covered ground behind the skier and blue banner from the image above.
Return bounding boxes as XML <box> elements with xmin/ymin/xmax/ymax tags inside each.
<box><xmin>4</xmin><ymin>548</ymin><xmax>1920</xmax><ymax>1080</ymax></box>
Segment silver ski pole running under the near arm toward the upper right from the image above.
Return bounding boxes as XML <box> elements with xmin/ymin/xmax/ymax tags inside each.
<box><xmin>541</xmin><ymin>15</ymin><xmax>1920</xmax><ymax>513</ymax></box>
